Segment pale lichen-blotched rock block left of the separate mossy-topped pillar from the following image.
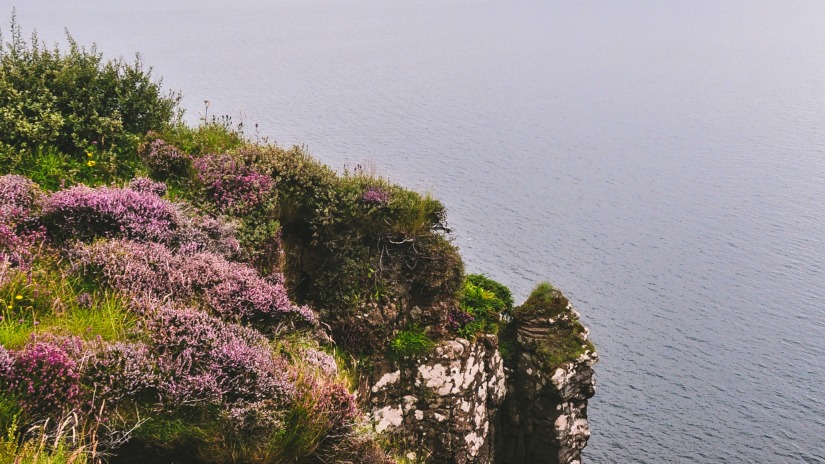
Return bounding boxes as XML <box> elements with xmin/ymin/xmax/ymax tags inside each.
<box><xmin>367</xmin><ymin>335</ymin><xmax>505</xmax><ymax>464</ymax></box>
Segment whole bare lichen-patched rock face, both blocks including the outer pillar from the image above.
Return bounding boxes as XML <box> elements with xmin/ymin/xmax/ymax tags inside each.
<box><xmin>363</xmin><ymin>293</ymin><xmax>598</xmax><ymax>464</ymax></box>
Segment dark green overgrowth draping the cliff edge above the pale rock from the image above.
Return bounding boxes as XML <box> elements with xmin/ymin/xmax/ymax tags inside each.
<box><xmin>262</xmin><ymin>143</ymin><xmax>463</xmax><ymax>314</ymax></box>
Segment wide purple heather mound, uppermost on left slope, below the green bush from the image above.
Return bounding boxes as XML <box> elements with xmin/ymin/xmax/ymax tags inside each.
<box><xmin>41</xmin><ymin>186</ymin><xmax>180</xmax><ymax>243</ymax></box>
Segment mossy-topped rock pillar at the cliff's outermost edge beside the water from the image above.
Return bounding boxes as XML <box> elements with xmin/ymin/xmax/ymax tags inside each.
<box><xmin>495</xmin><ymin>297</ymin><xmax>598</xmax><ymax>464</ymax></box>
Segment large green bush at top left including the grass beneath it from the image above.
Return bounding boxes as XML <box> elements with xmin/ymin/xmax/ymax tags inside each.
<box><xmin>0</xmin><ymin>17</ymin><xmax>179</xmax><ymax>186</ymax></box>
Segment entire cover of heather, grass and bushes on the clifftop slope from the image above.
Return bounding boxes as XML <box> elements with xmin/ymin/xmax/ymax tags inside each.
<box><xmin>0</xmin><ymin>18</ymin><xmax>592</xmax><ymax>463</ymax></box>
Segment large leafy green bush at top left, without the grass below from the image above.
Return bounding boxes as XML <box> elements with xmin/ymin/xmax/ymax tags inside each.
<box><xmin>0</xmin><ymin>18</ymin><xmax>179</xmax><ymax>156</ymax></box>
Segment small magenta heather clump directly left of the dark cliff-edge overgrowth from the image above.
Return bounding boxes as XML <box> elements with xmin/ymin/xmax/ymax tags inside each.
<box><xmin>195</xmin><ymin>154</ymin><xmax>275</xmax><ymax>214</ymax></box>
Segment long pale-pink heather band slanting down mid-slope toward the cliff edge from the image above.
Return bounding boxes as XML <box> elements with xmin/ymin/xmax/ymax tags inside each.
<box><xmin>74</xmin><ymin>240</ymin><xmax>317</xmax><ymax>324</ymax></box>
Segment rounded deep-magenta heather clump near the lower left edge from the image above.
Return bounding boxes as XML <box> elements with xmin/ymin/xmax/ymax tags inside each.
<box><xmin>8</xmin><ymin>342</ymin><xmax>80</xmax><ymax>415</ymax></box>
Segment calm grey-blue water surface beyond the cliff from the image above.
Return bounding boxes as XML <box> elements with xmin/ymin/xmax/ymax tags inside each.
<box><xmin>8</xmin><ymin>0</ymin><xmax>825</xmax><ymax>463</ymax></box>
